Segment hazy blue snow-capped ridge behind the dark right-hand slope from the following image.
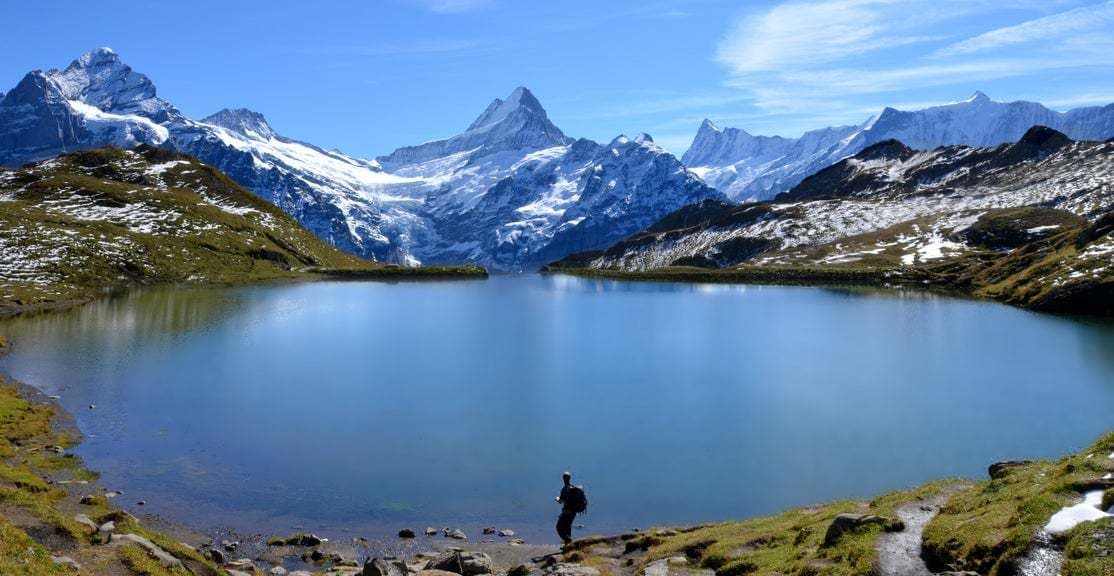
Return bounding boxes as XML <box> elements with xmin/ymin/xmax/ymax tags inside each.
<box><xmin>683</xmin><ymin>92</ymin><xmax>1114</xmax><ymax>201</ymax></box>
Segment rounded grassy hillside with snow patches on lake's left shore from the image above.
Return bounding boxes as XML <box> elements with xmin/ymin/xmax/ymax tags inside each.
<box><xmin>0</xmin><ymin>147</ymin><xmax>483</xmax><ymax>310</ymax></box>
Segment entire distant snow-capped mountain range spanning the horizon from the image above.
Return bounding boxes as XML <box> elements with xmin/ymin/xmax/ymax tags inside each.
<box><xmin>0</xmin><ymin>48</ymin><xmax>1114</xmax><ymax>271</ymax></box>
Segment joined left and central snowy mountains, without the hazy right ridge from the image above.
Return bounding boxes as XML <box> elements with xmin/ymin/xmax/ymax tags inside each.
<box><xmin>0</xmin><ymin>48</ymin><xmax>723</xmax><ymax>270</ymax></box>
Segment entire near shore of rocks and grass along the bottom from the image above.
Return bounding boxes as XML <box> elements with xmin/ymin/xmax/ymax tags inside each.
<box><xmin>0</xmin><ymin>329</ymin><xmax>1114</xmax><ymax>576</ymax></box>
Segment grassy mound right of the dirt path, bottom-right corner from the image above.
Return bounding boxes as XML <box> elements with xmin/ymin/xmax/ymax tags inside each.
<box><xmin>925</xmin><ymin>432</ymin><xmax>1114</xmax><ymax>576</ymax></box>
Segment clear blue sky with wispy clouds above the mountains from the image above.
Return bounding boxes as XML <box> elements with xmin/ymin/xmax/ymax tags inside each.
<box><xmin>0</xmin><ymin>0</ymin><xmax>1114</xmax><ymax>156</ymax></box>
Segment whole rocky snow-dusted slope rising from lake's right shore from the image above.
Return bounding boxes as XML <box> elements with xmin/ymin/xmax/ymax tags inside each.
<box><xmin>551</xmin><ymin>127</ymin><xmax>1114</xmax><ymax>314</ymax></box>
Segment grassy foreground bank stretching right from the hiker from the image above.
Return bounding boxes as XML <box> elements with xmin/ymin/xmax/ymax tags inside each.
<box><xmin>560</xmin><ymin>432</ymin><xmax>1114</xmax><ymax>576</ymax></box>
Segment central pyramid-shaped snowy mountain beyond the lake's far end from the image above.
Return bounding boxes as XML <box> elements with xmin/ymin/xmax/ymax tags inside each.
<box><xmin>379</xmin><ymin>92</ymin><xmax>723</xmax><ymax>270</ymax></box>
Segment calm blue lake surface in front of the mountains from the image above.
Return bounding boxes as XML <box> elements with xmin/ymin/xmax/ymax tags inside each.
<box><xmin>0</xmin><ymin>275</ymin><xmax>1114</xmax><ymax>541</ymax></box>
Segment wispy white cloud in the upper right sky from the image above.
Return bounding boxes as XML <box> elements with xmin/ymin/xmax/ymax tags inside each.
<box><xmin>715</xmin><ymin>0</ymin><xmax>1114</xmax><ymax>133</ymax></box>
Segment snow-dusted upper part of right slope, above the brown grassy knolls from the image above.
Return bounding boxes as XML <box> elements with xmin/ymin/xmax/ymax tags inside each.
<box><xmin>568</xmin><ymin>126</ymin><xmax>1114</xmax><ymax>271</ymax></box>
